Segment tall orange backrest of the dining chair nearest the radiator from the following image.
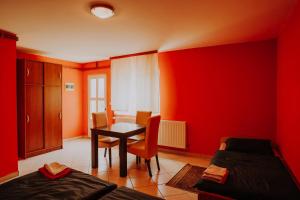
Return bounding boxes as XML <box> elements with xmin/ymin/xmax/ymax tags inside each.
<box><xmin>145</xmin><ymin>115</ymin><xmax>160</xmax><ymax>157</ymax></box>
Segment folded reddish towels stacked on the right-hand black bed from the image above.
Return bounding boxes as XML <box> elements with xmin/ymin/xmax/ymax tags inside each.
<box><xmin>202</xmin><ymin>165</ymin><xmax>229</xmax><ymax>184</ymax></box>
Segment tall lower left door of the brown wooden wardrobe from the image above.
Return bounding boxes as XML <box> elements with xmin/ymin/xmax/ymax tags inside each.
<box><xmin>25</xmin><ymin>85</ymin><xmax>44</xmax><ymax>153</ymax></box>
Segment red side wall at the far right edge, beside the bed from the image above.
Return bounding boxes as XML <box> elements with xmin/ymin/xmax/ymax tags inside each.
<box><xmin>276</xmin><ymin>3</ymin><xmax>300</xmax><ymax>182</ymax></box>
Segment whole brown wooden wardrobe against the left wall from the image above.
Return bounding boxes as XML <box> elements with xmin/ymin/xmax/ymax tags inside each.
<box><xmin>17</xmin><ymin>59</ymin><xmax>62</xmax><ymax>158</ymax></box>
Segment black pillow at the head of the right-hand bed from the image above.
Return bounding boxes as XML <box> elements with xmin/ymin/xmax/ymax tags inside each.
<box><xmin>225</xmin><ymin>138</ymin><xmax>274</xmax><ymax>155</ymax></box>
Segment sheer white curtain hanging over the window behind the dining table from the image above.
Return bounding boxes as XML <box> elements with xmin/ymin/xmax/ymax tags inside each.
<box><xmin>111</xmin><ymin>53</ymin><xmax>160</xmax><ymax>115</ymax></box>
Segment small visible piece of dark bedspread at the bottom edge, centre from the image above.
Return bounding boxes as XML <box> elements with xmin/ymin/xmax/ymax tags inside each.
<box><xmin>99</xmin><ymin>187</ymin><xmax>162</xmax><ymax>200</ymax></box>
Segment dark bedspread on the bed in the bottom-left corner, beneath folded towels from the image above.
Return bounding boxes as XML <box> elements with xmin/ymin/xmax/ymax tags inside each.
<box><xmin>0</xmin><ymin>170</ymin><xmax>117</xmax><ymax>200</ymax></box>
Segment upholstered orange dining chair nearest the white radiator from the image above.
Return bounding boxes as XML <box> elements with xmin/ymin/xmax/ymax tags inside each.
<box><xmin>127</xmin><ymin>116</ymin><xmax>160</xmax><ymax>177</ymax></box>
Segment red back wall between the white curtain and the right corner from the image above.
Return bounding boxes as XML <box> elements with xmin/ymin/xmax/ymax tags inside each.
<box><xmin>159</xmin><ymin>40</ymin><xmax>276</xmax><ymax>154</ymax></box>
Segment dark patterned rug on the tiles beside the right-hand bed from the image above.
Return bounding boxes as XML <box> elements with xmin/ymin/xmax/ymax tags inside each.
<box><xmin>166</xmin><ymin>164</ymin><xmax>206</xmax><ymax>193</ymax></box>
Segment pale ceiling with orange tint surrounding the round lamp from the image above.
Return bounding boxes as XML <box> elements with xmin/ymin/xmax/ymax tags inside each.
<box><xmin>0</xmin><ymin>0</ymin><xmax>297</xmax><ymax>63</ymax></box>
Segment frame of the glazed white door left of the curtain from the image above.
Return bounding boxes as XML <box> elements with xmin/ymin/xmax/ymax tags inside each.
<box><xmin>87</xmin><ymin>73</ymin><xmax>108</xmax><ymax>137</ymax></box>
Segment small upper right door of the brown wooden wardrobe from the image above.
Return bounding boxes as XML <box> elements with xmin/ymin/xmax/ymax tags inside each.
<box><xmin>44</xmin><ymin>63</ymin><xmax>62</xmax><ymax>86</ymax></box>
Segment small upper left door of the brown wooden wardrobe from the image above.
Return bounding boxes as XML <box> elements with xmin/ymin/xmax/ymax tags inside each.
<box><xmin>24</xmin><ymin>60</ymin><xmax>44</xmax><ymax>85</ymax></box>
